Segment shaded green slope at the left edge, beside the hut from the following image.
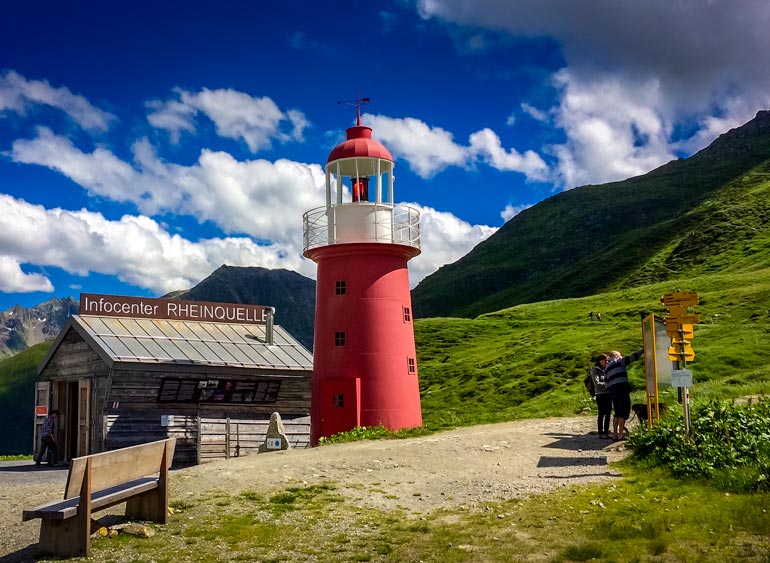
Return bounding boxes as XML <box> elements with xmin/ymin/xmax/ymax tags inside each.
<box><xmin>0</xmin><ymin>342</ymin><xmax>51</xmax><ymax>455</ymax></box>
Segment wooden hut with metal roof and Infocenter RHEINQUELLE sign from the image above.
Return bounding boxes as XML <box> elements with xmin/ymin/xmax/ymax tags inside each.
<box><xmin>35</xmin><ymin>294</ymin><xmax>313</xmax><ymax>464</ymax></box>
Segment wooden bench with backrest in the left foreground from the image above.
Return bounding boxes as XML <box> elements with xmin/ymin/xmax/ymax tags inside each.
<box><xmin>22</xmin><ymin>438</ymin><xmax>176</xmax><ymax>557</ymax></box>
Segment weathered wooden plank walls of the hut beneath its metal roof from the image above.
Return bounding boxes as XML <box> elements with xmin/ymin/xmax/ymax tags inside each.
<box><xmin>40</xmin><ymin>330</ymin><xmax>311</xmax><ymax>464</ymax></box>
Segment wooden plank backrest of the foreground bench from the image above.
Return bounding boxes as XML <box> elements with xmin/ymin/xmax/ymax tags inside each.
<box><xmin>64</xmin><ymin>438</ymin><xmax>176</xmax><ymax>499</ymax></box>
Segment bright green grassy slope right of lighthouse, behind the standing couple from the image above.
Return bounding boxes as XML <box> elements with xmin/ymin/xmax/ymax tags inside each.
<box><xmin>415</xmin><ymin>268</ymin><xmax>770</xmax><ymax>428</ymax></box>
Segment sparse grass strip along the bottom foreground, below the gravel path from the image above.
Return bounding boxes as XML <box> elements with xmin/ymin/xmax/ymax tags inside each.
<box><xmin>85</xmin><ymin>468</ymin><xmax>770</xmax><ymax>563</ymax></box>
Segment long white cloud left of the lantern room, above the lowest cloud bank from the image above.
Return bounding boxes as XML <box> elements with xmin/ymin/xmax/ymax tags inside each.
<box><xmin>11</xmin><ymin>128</ymin><xmax>325</xmax><ymax>245</ymax></box>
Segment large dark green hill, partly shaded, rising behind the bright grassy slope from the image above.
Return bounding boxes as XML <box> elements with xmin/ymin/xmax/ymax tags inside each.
<box><xmin>412</xmin><ymin>111</ymin><xmax>770</xmax><ymax>318</ymax></box>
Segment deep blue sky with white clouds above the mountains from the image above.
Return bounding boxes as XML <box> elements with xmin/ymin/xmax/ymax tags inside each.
<box><xmin>0</xmin><ymin>0</ymin><xmax>770</xmax><ymax>311</ymax></box>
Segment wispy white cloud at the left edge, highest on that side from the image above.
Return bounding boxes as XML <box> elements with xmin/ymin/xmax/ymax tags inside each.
<box><xmin>0</xmin><ymin>70</ymin><xmax>115</xmax><ymax>132</ymax></box>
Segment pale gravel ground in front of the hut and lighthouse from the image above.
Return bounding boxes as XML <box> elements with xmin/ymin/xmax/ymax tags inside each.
<box><xmin>0</xmin><ymin>417</ymin><xmax>627</xmax><ymax>563</ymax></box>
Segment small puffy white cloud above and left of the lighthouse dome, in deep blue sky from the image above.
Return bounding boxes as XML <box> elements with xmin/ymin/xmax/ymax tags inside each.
<box><xmin>147</xmin><ymin>88</ymin><xmax>310</xmax><ymax>153</ymax></box>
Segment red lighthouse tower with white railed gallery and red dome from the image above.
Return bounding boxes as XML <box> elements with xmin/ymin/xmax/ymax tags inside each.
<box><xmin>303</xmin><ymin>104</ymin><xmax>422</xmax><ymax>444</ymax></box>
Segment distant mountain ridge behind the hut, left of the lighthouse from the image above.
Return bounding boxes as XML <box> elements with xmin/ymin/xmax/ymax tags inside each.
<box><xmin>0</xmin><ymin>265</ymin><xmax>315</xmax><ymax>358</ymax></box>
